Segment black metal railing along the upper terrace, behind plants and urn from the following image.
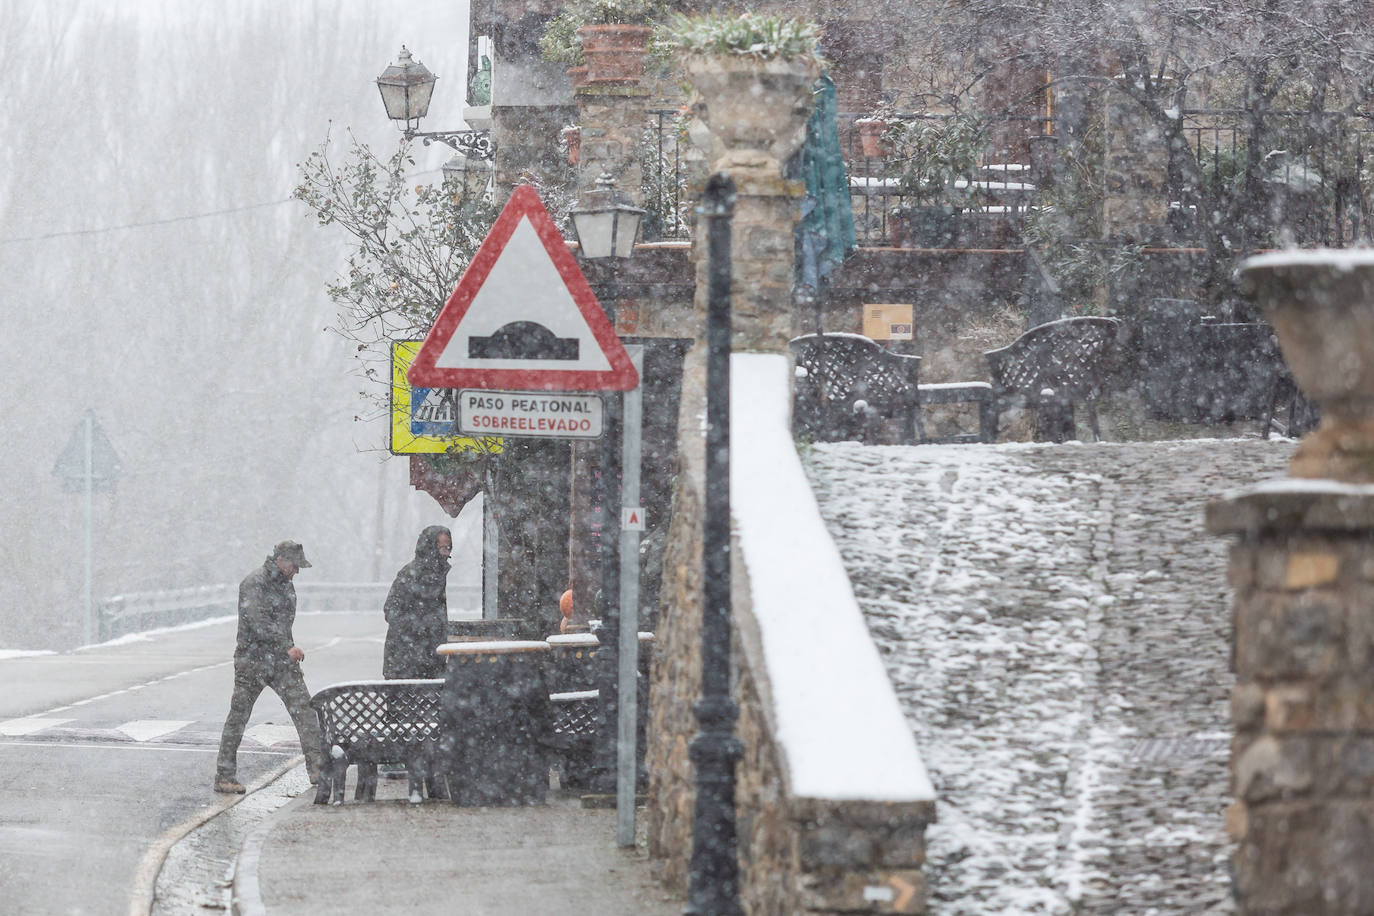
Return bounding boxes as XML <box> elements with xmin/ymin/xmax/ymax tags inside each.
<box><xmin>642</xmin><ymin>108</ymin><xmax>1374</xmax><ymax>249</ymax></box>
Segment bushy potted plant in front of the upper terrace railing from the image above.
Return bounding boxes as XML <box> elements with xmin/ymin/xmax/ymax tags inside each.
<box><xmin>882</xmin><ymin>114</ymin><xmax>988</xmax><ymax>246</ymax></box>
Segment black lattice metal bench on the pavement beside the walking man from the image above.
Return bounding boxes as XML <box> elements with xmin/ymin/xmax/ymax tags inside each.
<box><xmin>311</xmin><ymin>678</ymin><xmax>444</xmax><ymax>805</ymax></box>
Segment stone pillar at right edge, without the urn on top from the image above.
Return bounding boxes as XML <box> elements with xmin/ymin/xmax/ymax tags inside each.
<box><xmin>1208</xmin><ymin>491</ymin><xmax>1374</xmax><ymax>916</ymax></box>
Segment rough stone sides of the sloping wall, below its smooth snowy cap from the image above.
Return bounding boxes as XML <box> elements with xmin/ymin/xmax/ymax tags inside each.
<box><xmin>646</xmin><ymin>349</ymin><xmax>934</xmax><ymax>916</ymax></box>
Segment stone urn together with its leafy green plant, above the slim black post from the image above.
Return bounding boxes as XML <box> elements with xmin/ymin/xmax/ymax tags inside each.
<box><xmin>660</xmin><ymin>12</ymin><xmax>823</xmax><ymax>172</ymax></box>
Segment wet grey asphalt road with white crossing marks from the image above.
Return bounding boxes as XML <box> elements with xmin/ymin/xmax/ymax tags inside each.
<box><xmin>0</xmin><ymin>612</ymin><xmax>385</xmax><ymax>915</ymax></box>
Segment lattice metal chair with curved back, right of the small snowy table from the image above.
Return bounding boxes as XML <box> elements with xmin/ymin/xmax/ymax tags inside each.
<box><xmin>984</xmin><ymin>317</ymin><xmax>1121</xmax><ymax>442</ymax></box>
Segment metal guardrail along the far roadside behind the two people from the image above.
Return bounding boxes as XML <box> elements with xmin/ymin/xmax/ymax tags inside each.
<box><xmin>99</xmin><ymin>582</ymin><xmax>482</xmax><ymax>640</ymax></box>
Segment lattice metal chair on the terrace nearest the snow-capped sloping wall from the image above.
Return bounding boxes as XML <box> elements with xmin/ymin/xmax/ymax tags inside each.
<box><xmin>791</xmin><ymin>334</ymin><xmax>921</xmax><ymax>445</ymax></box>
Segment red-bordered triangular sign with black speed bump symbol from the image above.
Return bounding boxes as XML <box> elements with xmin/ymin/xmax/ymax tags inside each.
<box><xmin>407</xmin><ymin>185</ymin><xmax>639</xmax><ymax>391</ymax></box>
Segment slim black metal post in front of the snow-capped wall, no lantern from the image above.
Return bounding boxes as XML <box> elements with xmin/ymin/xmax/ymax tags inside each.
<box><xmin>683</xmin><ymin>174</ymin><xmax>743</xmax><ymax>916</ymax></box>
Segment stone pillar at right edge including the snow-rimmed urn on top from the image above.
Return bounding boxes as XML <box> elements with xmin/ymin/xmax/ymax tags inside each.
<box><xmin>1208</xmin><ymin>251</ymin><xmax>1374</xmax><ymax>916</ymax></box>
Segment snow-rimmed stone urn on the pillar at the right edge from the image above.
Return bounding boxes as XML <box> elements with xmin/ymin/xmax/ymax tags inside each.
<box><xmin>1241</xmin><ymin>249</ymin><xmax>1374</xmax><ymax>483</ymax></box>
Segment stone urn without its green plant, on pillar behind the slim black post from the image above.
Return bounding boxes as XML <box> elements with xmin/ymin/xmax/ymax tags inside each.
<box><xmin>686</xmin><ymin>55</ymin><xmax>819</xmax><ymax>174</ymax></box>
